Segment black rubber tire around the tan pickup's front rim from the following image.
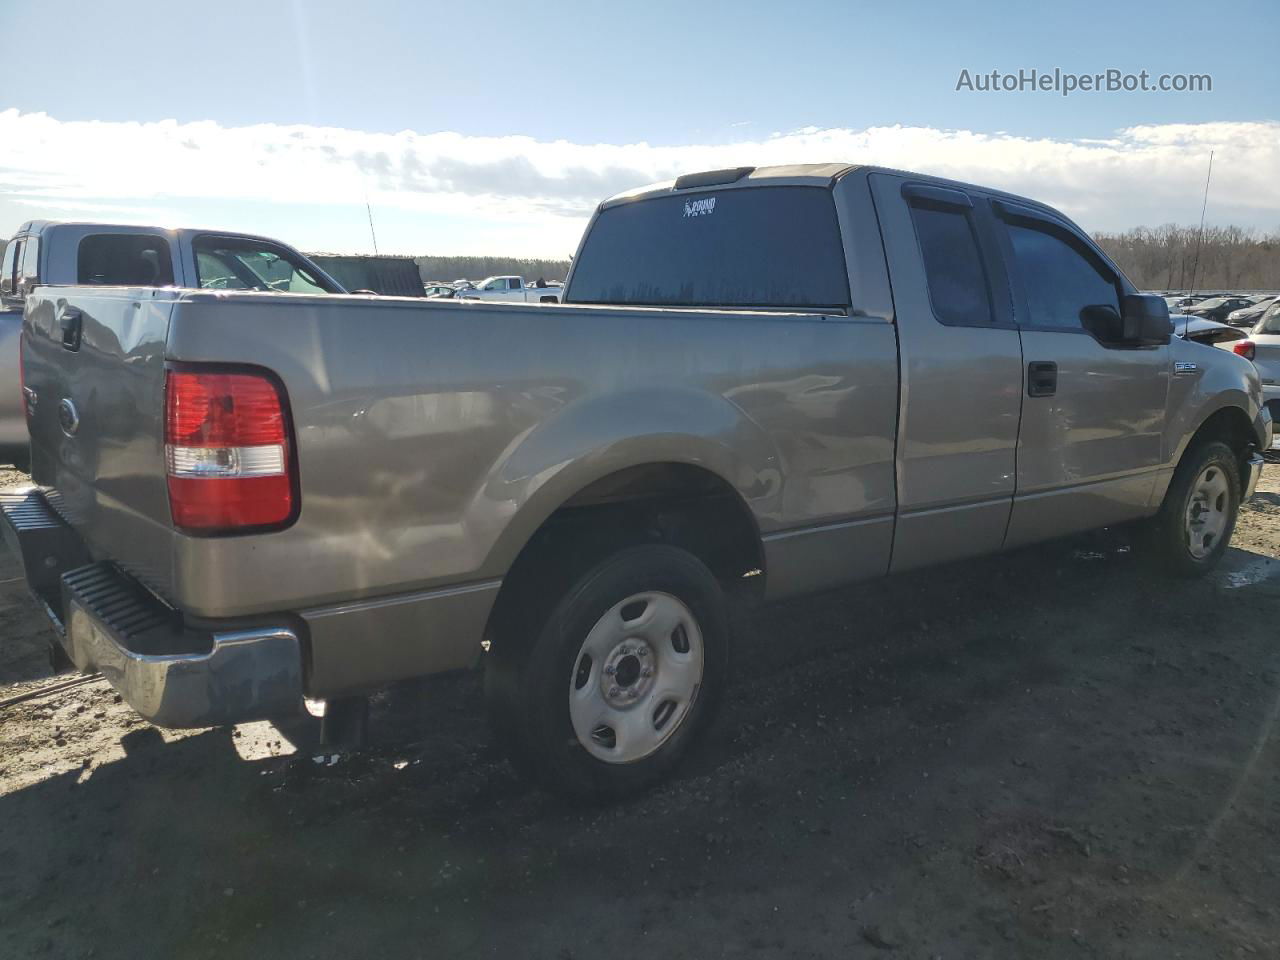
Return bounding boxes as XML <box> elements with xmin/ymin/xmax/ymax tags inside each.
<box><xmin>1147</xmin><ymin>440</ymin><xmax>1240</xmax><ymax>577</ymax></box>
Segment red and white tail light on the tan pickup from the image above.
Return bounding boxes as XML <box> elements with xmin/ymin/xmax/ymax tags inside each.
<box><xmin>164</xmin><ymin>369</ymin><xmax>297</xmax><ymax>534</ymax></box>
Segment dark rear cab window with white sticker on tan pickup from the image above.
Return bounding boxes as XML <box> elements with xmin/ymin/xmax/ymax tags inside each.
<box><xmin>564</xmin><ymin>187</ymin><xmax>849</xmax><ymax>310</ymax></box>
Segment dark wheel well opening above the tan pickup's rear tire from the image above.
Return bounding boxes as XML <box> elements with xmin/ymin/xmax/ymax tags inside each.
<box><xmin>486</xmin><ymin>463</ymin><xmax>764</xmax><ymax>643</ymax></box>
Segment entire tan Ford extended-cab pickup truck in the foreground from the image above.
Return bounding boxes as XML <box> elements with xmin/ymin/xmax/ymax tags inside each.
<box><xmin>5</xmin><ymin>164</ymin><xmax>1271</xmax><ymax>796</ymax></box>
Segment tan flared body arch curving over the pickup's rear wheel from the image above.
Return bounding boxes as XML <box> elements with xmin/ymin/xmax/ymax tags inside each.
<box><xmin>465</xmin><ymin>387</ymin><xmax>782</xmax><ymax>577</ymax></box>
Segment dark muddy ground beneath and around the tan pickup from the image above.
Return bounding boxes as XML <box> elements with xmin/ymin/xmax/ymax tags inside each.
<box><xmin>0</xmin><ymin>466</ymin><xmax>1280</xmax><ymax>960</ymax></box>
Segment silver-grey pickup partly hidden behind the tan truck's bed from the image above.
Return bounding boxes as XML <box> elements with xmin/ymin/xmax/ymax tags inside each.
<box><xmin>0</xmin><ymin>220</ymin><xmax>344</xmax><ymax>468</ymax></box>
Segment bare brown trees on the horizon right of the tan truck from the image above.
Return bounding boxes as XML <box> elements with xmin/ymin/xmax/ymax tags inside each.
<box><xmin>1093</xmin><ymin>224</ymin><xmax>1280</xmax><ymax>291</ymax></box>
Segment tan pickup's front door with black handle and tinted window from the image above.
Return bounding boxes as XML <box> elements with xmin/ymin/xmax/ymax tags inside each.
<box><xmin>993</xmin><ymin>201</ymin><xmax>1170</xmax><ymax>547</ymax></box>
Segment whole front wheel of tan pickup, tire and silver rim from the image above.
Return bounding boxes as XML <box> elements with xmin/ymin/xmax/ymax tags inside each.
<box><xmin>1151</xmin><ymin>440</ymin><xmax>1240</xmax><ymax>577</ymax></box>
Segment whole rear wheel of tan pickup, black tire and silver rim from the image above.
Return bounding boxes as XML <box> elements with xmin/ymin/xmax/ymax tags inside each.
<box><xmin>485</xmin><ymin>544</ymin><xmax>728</xmax><ymax>800</ymax></box>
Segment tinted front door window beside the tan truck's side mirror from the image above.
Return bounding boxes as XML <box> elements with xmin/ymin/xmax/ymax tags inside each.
<box><xmin>1007</xmin><ymin>221</ymin><xmax>1120</xmax><ymax>329</ymax></box>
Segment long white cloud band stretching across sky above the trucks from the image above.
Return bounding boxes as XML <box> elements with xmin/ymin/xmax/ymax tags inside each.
<box><xmin>0</xmin><ymin>110</ymin><xmax>1280</xmax><ymax>256</ymax></box>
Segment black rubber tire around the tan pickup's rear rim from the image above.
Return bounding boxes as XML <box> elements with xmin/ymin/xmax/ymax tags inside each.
<box><xmin>485</xmin><ymin>544</ymin><xmax>728</xmax><ymax>801</ymax></box>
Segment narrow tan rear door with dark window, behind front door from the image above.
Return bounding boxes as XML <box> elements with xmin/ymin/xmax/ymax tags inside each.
<box><xmin>869</xmin><ymin>173</ymin><xmax>1023</xmax><ymax>571</ymax></box>
